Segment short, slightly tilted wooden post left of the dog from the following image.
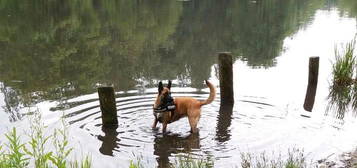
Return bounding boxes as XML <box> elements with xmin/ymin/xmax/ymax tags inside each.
<box><xmin>98</xmin><ymin>87</ymin><xmax>118</xmax><ymax>127</ymax></box>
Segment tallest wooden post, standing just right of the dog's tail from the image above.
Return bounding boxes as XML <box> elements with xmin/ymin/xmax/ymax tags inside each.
<box><xmin>218</xmin><ymin>52</ymin><xmax>234</xmax><ymax>106</ymax></box>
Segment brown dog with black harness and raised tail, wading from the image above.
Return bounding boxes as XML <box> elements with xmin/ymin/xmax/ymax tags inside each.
<box><xmin>152</xmin><ymin>80</ymin><xmax>216</xmax><ymax>133</ymax></box>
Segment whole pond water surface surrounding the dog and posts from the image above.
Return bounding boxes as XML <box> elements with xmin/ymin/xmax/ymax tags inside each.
<box><xmin>0</xmin><ymin>0</ymin><xmax>357</xmax><ymax>167</ymax></box>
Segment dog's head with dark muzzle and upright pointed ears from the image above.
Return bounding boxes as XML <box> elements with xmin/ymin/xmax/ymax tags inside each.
<box><xmin>154</xmin><ymin>80</ymin><xmax>173</xmax><ymax>108</ymax></box>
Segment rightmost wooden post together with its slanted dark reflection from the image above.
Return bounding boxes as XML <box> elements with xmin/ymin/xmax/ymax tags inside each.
<box><xmin>304</xmin><ymin>57</ymin><xmax>320</xmax><ymax>112</ymax></box>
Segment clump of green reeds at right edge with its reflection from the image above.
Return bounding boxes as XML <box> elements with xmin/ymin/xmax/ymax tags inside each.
<box><xmin>327</xmin><ymin>37</ymin><xmax>357</xmax><ymax>119</ymax></box>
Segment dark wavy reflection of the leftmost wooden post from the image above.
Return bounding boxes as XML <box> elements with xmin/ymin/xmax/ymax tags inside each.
<box><xmin>98</xmin><ymin>127</ymin><xmax>120</xmax><ymax>156</ymax></box>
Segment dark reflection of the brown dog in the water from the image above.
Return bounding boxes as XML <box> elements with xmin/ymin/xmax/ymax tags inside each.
<box><xmin>154</xmin><ymin>133</ymin><xmax>200</xmax><ymax>168</ymax></box>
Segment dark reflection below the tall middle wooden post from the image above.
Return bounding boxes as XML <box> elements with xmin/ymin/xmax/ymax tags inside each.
<box><xmin>216</xmin><ymin>105</ymin><xmax>233</xmax><ymax>142</ymax></box>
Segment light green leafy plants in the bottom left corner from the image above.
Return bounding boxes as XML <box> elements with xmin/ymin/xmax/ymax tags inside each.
<box><xmin>0</xmin><ymin>115</ymin><xmax>91</xmax><ymax>168</ymax></box>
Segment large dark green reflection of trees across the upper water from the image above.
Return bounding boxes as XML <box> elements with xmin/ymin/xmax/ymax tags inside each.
<box><xmin>0</xmin><ymin>0</ymin><xmax>323</xmax><ymax>109</ymax></box>
